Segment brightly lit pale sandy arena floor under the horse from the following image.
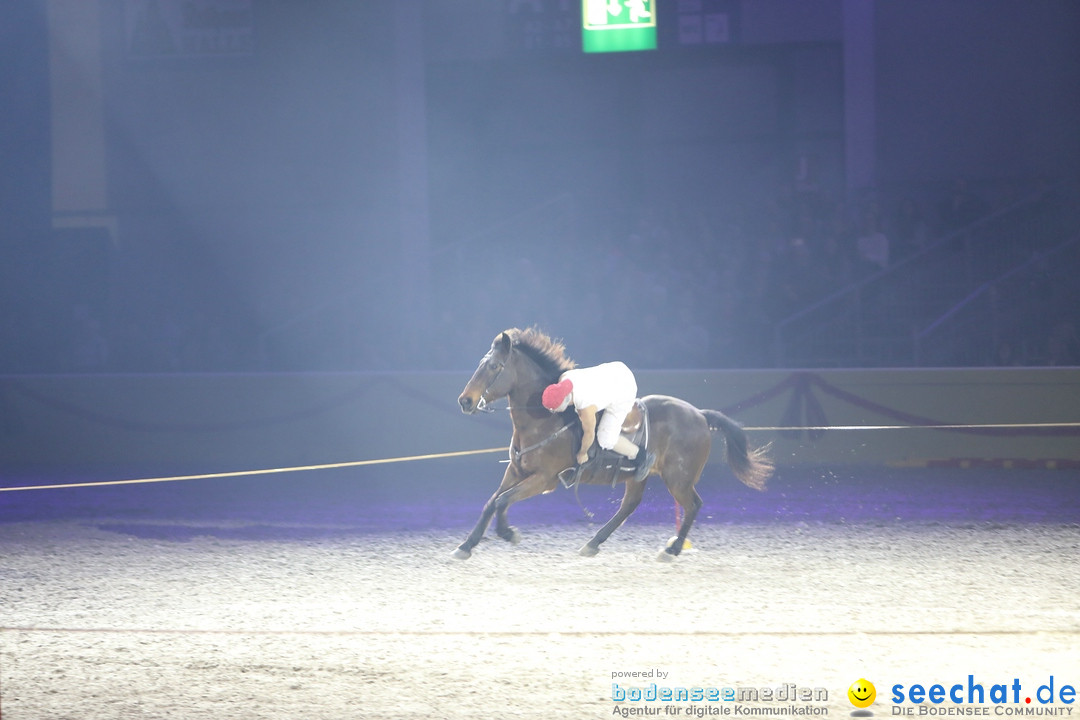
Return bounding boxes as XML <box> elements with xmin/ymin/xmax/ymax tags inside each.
<box><xmin>0</xmin><ymin>464</ymin><xmax>1080</xmax><ymax>720</ymax></box>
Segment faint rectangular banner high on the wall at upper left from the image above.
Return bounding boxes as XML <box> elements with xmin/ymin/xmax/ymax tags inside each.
<box><xmin>124</xmin><ymin>0</ymin><xmax>255</xmax><ymax>58</ymax></box>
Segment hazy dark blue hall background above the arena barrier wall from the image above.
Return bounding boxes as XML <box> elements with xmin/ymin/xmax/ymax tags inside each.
<box><xmin>0</xmin><ymin>0</ymin><xmax>1080</xmax><ymax>372</ymax></box>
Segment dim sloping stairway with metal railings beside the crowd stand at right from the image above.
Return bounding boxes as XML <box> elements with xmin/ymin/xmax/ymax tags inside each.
<box><xmin>772</xmin><ymin>181</ymin><xmax>1078</xmax><ymax>367</ymax></box>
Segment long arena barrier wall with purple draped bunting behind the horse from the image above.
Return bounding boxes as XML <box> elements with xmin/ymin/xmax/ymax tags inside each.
<box><xmin>0</xmin><ymin>368</ymin><xmax>1080</xmax><ymax>476</ymax></box>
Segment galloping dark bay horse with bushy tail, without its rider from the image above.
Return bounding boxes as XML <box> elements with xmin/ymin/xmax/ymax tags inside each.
<box><xmin>454</xmin><ymin>328</ymin><xmax>772</xmax><ymax>559</ymax></box>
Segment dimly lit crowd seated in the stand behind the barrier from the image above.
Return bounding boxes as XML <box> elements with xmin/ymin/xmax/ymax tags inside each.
<box><xmin>54</xmin><ymin>181</ymin><xmax>1080</xmax><ymax>371</ymax></box>
